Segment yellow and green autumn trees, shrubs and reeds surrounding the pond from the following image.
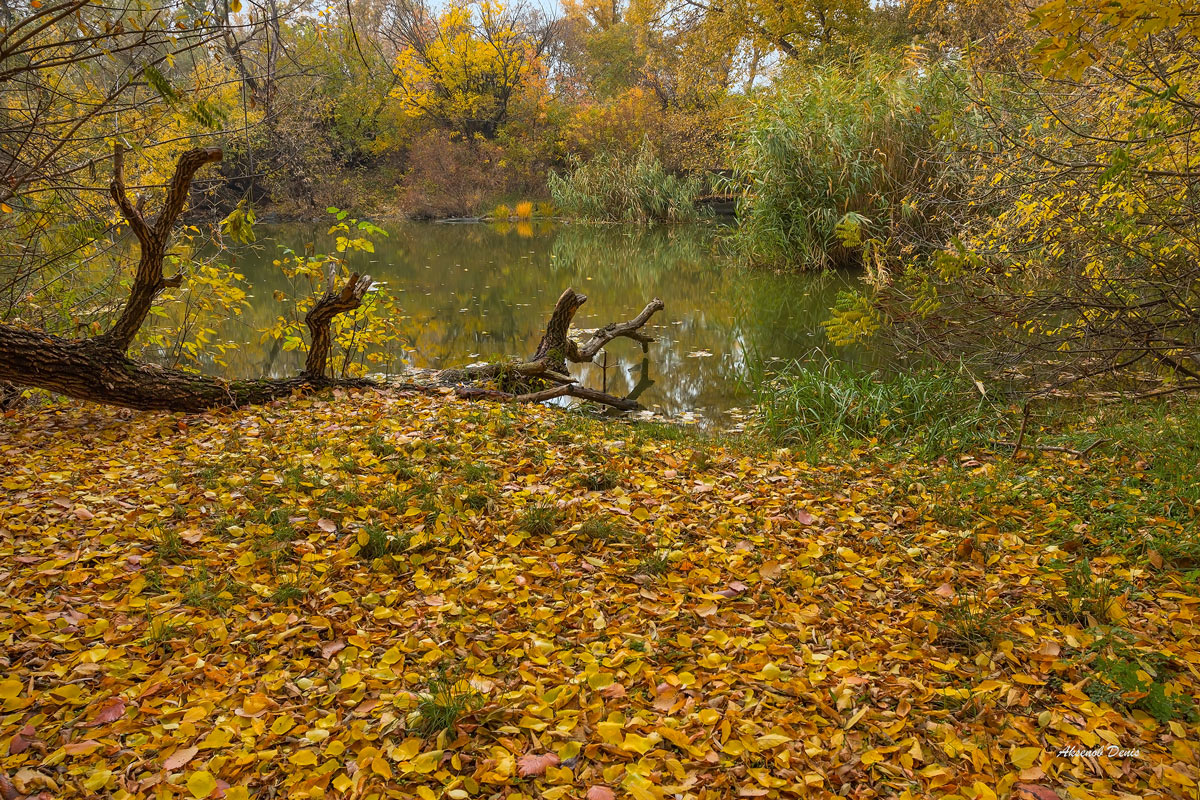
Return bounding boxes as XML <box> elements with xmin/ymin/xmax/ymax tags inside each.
<box><xmin>7</xmin><ymin>0</ymin><xmax>1200</xmax><ymax>396</ymax></box>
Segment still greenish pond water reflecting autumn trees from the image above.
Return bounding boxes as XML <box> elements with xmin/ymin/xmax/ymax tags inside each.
<box><xmin>208</xmin><ymin>222</ymin><xmax>869</xmax><ymax>420</ymax></box>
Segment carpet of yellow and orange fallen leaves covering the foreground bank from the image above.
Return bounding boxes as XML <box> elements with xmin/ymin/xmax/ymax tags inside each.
<box><xmin>0</xmin><ymin>393</ymin><xmax>1200</xmax><ymax>800</ymax></box>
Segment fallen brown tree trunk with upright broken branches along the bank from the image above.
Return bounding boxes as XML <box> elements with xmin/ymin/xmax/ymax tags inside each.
<box><xmin>0</xmin><ymin>145</ymin><xmax>662</xmax><ymax>411</ymax></box>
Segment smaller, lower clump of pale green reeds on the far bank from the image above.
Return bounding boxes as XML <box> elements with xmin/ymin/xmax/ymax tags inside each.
<box><xmin>548</xmin><ymin>142</ymin><xmax>703</xmax><ymax>223</ymax></box>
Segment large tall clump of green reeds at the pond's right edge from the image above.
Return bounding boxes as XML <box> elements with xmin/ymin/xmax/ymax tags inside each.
<box><xmin>730</xmin><ymin>59</ymin><xmax>961</xmax><ymax>270</ymax></box>
